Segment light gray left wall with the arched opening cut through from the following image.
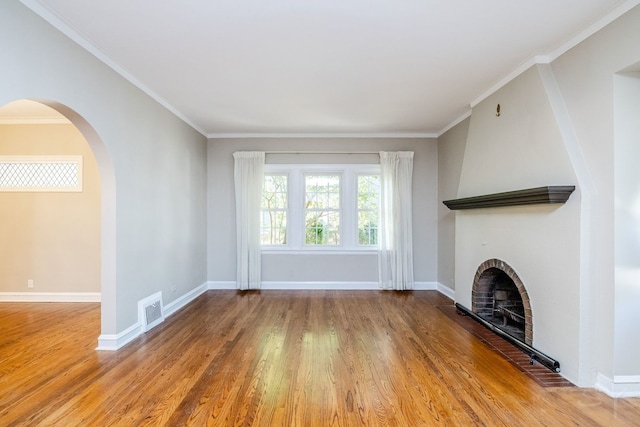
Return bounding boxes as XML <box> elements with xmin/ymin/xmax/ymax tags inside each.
<box><xmin>0</xmin><ymin>1</ymin><xmax>206</xmax><ymax>335</ymax></box>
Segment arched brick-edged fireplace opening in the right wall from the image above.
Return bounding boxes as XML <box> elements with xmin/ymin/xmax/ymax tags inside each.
<box><xmin>471</xmin><ymin>259</ymin><xmax>533</xmax><ymax>345</ymax></box>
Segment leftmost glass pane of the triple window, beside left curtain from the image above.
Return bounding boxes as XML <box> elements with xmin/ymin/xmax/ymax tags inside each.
<box><xmin>260</xmin><ymin>175</ymin><xmax>287</xmax><ymax>245</ymax></box>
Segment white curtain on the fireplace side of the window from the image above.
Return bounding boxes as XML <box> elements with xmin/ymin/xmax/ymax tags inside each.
<box><xmin>378</xmin><ymin>151</ymin><xmax>413</xmax><ymax>290</ymax></box>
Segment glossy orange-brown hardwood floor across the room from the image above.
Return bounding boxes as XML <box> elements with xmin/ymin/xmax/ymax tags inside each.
<box><xmin>0</xmin><ymin>291</ymin><xmax>640</xmax><ymax>426</ymax></box>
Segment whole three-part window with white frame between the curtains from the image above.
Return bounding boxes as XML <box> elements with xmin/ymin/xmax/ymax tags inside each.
<box><xmin>260</xmin><ymin>164</ymin><xmax>380</xmax><ymax>251</ymax></box>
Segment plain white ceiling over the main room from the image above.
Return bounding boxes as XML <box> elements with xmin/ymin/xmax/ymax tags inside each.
<box><xmin>22</xmin><ymin>0</ymin><xmax>639</xmax><ymax>137</ymax></box>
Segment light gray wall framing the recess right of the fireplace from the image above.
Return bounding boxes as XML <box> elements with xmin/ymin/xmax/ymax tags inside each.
<box><xmin>552</xmin><ymin>6</ymin><xmax>640</xmax><ymax>384</ymax></box>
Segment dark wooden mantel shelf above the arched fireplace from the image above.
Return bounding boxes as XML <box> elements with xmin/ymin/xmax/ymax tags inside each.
<box><xmin>442</xmin><ymin>185</ymin><xmax>576</xmax><ymax>210</ymax></box>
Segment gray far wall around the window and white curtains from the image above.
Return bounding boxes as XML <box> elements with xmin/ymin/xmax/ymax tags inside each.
<box><xmin>208</xmin><ymin>138</ymin><xmax>438</xmax><ymax>284</ymax></box>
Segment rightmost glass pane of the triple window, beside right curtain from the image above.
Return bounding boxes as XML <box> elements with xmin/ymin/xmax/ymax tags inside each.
<box><xmin>358</xmin><ymin>175</ymin><xmax>380</xmax><ymax>245</ymax></box>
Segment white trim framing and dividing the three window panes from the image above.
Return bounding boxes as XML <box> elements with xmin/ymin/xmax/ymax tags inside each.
<box><xmin>262</xmin><ymin>163</ymin><xmax>380</xmax><ymax>255</ymax></box>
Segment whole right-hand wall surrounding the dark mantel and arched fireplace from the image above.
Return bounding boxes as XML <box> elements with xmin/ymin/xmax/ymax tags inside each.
<box><xmin>439</xmin><ymin>7</ymin><xmax>640</xmax><ymax>395</ymax></box>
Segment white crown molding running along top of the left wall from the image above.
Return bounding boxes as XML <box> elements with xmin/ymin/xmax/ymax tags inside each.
<box><xmin>20</xmin><ymin>0</ymin><xmax>206</xmax><ymax>136</ymax></box>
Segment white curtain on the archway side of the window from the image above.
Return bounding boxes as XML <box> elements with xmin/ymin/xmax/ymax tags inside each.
<box><xmin>233</xmin><ymin>151</ymin><xmax>265</xmax><ymax>290</ymax></box>
